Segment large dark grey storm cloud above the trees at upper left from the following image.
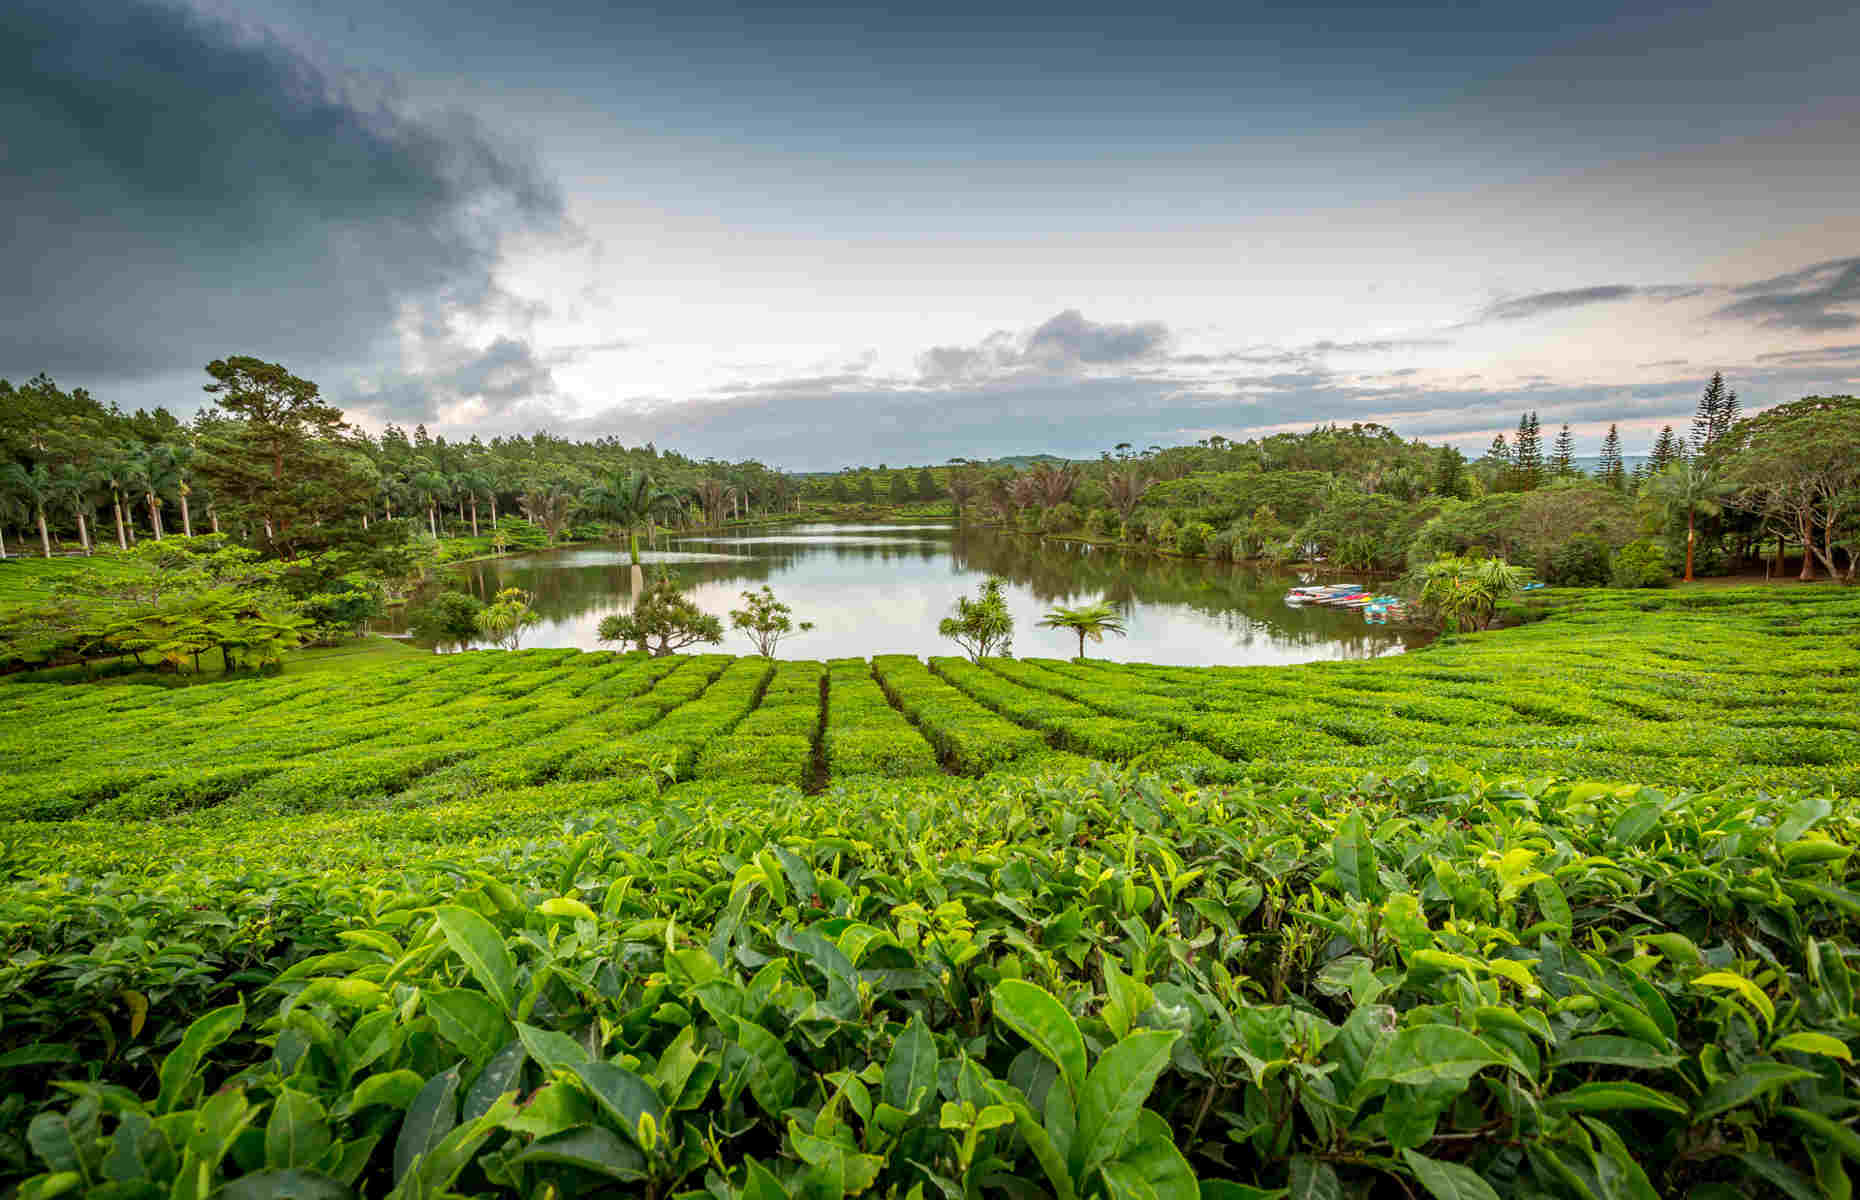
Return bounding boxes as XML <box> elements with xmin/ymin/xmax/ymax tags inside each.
<box><xmin>0</xmin><ymin>0</ymin><xmax>562</xmax><ymax>392</ymax></box>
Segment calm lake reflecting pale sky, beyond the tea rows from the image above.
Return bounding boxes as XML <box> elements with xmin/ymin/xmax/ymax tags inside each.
<box><xmin>387</xmin><ymin>523</ymin><xmax>1425</xmax><ymax>666</ymax></box>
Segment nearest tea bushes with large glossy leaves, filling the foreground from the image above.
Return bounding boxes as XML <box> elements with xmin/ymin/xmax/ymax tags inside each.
<box><xmin>0</xmin><ymin>768</ymin><xmax>1860</xmax><ymax>1200</ymax></box>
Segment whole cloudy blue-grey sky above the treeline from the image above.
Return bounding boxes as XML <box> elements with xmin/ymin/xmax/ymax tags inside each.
<box><xmin>0</xmin><ymin>0</ymin><xmax>1860</xmax><ymax>471</ymax></box>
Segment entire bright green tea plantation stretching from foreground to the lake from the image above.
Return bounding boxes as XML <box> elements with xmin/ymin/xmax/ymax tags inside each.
<box><xmin>0</xmin><ymin>588</ymin><xmax>1860</xmax><ymax>1200</ymax></box>
